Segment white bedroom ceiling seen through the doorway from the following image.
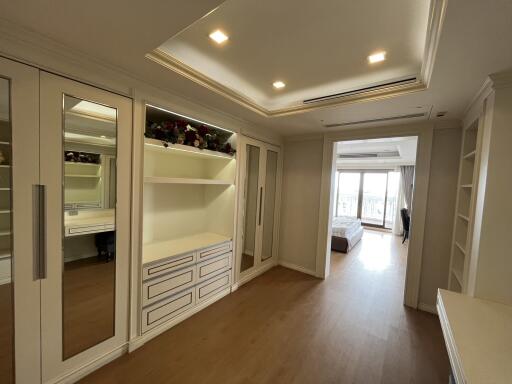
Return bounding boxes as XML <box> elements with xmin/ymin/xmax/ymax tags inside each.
<box><xmin>336</xmin><ymin>136</ymin><xmax>418</xmax><ymax>168</ymax></box>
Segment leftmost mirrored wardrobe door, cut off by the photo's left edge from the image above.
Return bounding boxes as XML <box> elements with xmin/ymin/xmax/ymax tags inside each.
<box><xmin>0</xmin><ymin>58</ymin><xmax>43</xmax><ymax>383</ymax></box>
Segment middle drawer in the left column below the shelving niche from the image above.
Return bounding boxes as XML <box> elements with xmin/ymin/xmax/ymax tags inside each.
<box><xmin>142</xmin><ymin>266</ymin><xmax>196</xmax><ymax>306</ymax></box>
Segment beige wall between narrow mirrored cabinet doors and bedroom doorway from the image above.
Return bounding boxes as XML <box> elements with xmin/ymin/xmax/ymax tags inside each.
<box><xmin>279</xmin><ymin>138</ymin><xmax>323</xmax><ymax>273</ymax></box>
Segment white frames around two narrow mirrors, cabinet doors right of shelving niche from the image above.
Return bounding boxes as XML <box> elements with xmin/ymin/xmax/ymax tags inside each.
<box><xmin>233</xmin><ymin>135</ymin><xmax>283</xmax><ymax>289</ymax></box>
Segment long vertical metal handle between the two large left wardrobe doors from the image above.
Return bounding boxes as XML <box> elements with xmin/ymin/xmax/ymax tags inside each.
<box><xmin>32</xmin><ymin>184</ymin><xmax>46</xmax><ymax>280</ymax></box>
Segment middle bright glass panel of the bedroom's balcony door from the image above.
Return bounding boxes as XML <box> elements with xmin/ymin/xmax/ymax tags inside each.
<box><xmin>361</xmin><ymin>172</ymin><xmax>388</xmax><ymax>226</ymax></box>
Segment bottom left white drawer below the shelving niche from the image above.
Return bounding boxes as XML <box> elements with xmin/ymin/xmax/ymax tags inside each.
<box><xmin>142</xmin><ymin>288</ymin><xmax>195</xmax><ymax>332</ymax></box>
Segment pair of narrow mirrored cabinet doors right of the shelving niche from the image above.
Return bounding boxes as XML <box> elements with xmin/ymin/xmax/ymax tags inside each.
<box><xmin>237</xmin><ymin>137</ymin><xmax>282</xmax><ymax>276</ymax></box>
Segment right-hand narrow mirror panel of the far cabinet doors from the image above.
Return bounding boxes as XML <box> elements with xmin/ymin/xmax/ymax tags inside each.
<box><xmin>261</xmin><ymin>150</ymin><xmax>278</xmax><ymax>260</ymax></box>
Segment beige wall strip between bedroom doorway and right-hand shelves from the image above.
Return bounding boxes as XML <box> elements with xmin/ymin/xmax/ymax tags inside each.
<box><xmin>419</xmin><ymin>128</ymin><xmax>462</xmax><ymax>307</ymax></box>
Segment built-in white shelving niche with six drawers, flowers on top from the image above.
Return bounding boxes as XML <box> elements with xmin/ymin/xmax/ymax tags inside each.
<box><xmin>141</xmin><ymin>105</ymin><xmax>237</xmax><ymax>335</ymax></box>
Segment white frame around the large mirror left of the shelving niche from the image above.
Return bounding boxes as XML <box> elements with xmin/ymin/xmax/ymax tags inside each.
<box><xmin>40</xmin><ymin>71</ymin><xmax>133</xmax><ymax>383</ymax></box>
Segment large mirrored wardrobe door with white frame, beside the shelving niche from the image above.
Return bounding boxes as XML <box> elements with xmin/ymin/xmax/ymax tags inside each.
<box><xmin>41</xmin><ymin>72</ymin><xmax>132</xmax><ymax>381</ymax></box>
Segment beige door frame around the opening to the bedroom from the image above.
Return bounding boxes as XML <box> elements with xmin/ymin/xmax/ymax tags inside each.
<box><xmin>316</xmin><ymin>123</ymin><xmax>434</xmax><ymax>308</ymax></box>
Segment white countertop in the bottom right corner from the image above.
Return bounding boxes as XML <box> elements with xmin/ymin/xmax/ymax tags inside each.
<box><xmin>437</xmin><ymin>289</ymin><xmax>512</xmax><ymax>384</ymax></box>
